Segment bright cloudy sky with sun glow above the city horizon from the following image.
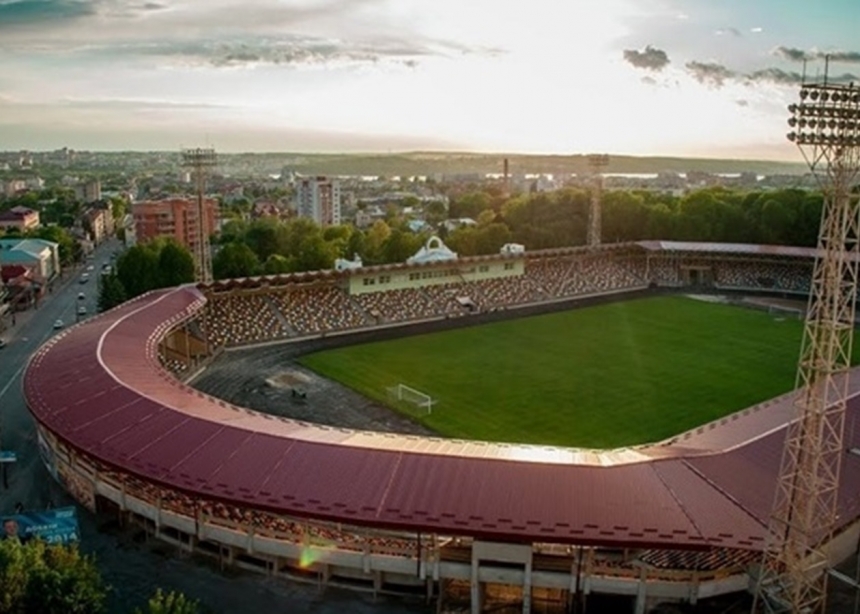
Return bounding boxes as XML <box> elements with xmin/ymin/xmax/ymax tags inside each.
<box><xmin>0</xmin><ymin>0</ymin><xmax>860</xmax><ymax>160</ymax></box>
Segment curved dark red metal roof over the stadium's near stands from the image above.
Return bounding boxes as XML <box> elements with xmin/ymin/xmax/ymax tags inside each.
<box><xmin>24</xmin><ymin>287</ymin><xmax>860</xmax><ymax>550</ymax></box>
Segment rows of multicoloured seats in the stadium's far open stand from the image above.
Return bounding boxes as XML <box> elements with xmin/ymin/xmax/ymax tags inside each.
<box><xmin>200</xmin><ymin>251</ymin><xmax>811</xmax><ymax>348</ymax></box>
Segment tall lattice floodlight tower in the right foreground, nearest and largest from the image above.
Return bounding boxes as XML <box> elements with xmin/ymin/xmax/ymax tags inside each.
<box><xmin>753</xmin><ymin>76</ymin><xmax>860</xmax><ymax>614</ymax></box>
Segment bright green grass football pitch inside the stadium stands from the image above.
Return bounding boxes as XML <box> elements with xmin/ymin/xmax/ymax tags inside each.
<box><xmin>301</xmin><ymin>297</ymin><xmax>844</xmax><ymax>448</ymax></box>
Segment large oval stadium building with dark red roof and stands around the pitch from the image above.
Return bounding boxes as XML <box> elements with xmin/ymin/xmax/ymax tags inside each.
<box><xmin>24</xmin><ymin>240</ymin><xmax>860</xmax><ymax>613</ymax></box>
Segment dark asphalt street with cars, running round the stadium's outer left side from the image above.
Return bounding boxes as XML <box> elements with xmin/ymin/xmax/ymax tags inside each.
<box><xmin>0</xmin><ymin>241</ymin><xmax>428</xmax><ymax>614</ymax></box>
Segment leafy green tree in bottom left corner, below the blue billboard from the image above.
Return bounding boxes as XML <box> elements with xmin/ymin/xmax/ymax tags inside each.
<box><xmin>0</xmin><ymin>539</ymin><xmax>108</xmax><ymax>614</ymax></box>
